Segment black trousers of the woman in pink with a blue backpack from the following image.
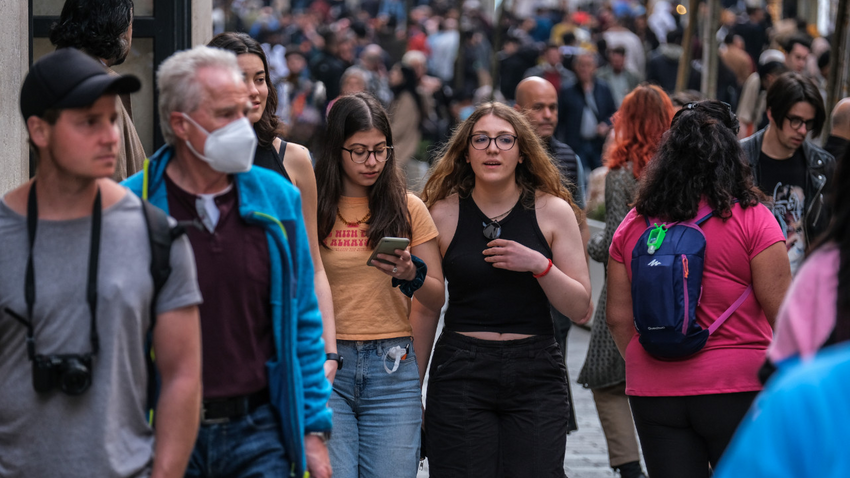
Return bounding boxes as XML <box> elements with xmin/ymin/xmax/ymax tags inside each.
<box><xmin>629</xmin><ymin>392</ymin><xmax>758</xmax><ymax>478</ymax></box>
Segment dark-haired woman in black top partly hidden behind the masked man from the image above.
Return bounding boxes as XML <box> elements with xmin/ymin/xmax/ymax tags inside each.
<box><xmin>207</xmin><ymin>32</ymin><xmax>337</xmax><ymax>382</ymax></box>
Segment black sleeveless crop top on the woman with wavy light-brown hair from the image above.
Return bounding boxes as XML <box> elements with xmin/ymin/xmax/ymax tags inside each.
<box><xmin>443</xmin><ymin>195</ymin><xmax>554</xmax><ymax>335</ymax></box>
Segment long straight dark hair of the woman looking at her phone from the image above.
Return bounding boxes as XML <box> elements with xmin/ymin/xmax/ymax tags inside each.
<box><xmin>316</xmin><ymin>93</ymin><xmax>412</xmax><ymax>249</ymax></box>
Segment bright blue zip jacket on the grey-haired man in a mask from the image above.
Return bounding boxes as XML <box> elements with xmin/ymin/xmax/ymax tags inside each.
<box><xmin>122</xmin><ymin>146</ymin><xmax>331</xmax><ymax>476</ymax></box>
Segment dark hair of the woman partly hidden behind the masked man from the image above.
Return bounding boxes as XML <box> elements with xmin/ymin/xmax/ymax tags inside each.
<box><xmin>207</xmin><ymin>32</ymin><xmax>283</xmax><ymax>148</ymax></box>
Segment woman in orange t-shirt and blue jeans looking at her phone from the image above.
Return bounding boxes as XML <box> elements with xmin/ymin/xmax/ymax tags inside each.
<box><xmin>316</xmin><ymin>93</ymin><xmax>445</xmax><ymax>478</ymax></box>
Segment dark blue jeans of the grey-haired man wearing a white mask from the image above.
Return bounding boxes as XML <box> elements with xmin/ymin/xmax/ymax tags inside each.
<box><xmin>186</xmin><ymin>404</ymin><xmax>290</xmax><ymax>478</ymax></box>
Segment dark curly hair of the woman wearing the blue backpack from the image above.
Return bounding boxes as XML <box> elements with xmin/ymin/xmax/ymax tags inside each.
<box><xmin>635</xmin><ymin>100</ymin><xmax>766</xmax><ymax>221</ymax></box>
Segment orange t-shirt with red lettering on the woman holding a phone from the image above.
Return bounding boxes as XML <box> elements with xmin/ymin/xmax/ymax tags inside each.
<box><xmin>320</xmin><ymin>193</ymin><xmax>437</xmax><ymax>340</ymax></box>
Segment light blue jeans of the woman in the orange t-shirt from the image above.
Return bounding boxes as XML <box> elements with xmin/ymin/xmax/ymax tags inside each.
<box><xmin>328</xmin><ymin>337</ymin><xmax>422</xmax><ymax>478</ymax></box>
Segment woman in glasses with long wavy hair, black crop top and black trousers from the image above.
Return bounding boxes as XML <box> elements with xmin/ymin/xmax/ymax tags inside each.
<box><xmin>411</xmin><ymin>103</ymin><xmax>590</xmax><ymax>477</ymax></box>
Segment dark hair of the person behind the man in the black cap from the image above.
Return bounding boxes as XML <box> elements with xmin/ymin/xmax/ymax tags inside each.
<box><xmin>50</xmin><ymin>0</ymin><xmax>133</xmax><ymax>61</ymax></box>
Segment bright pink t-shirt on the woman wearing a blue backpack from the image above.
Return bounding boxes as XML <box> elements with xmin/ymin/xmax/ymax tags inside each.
<box><xmin>608</xmin><ymin>204</ymin><xmax>784</xmax><ymax>397</ymax></box>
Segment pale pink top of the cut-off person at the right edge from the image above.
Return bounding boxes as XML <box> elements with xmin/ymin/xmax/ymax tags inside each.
<box><xmin>767</xmin><ymin>245</ymin><xmax>841</xmax><ymax>365</ymax></box>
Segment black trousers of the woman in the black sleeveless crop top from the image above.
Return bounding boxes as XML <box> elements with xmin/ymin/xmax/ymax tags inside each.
<box><xmin>425</xmin><ymin>331</ymin><xmax>570</xmax><ymax>478</ymax></box>
